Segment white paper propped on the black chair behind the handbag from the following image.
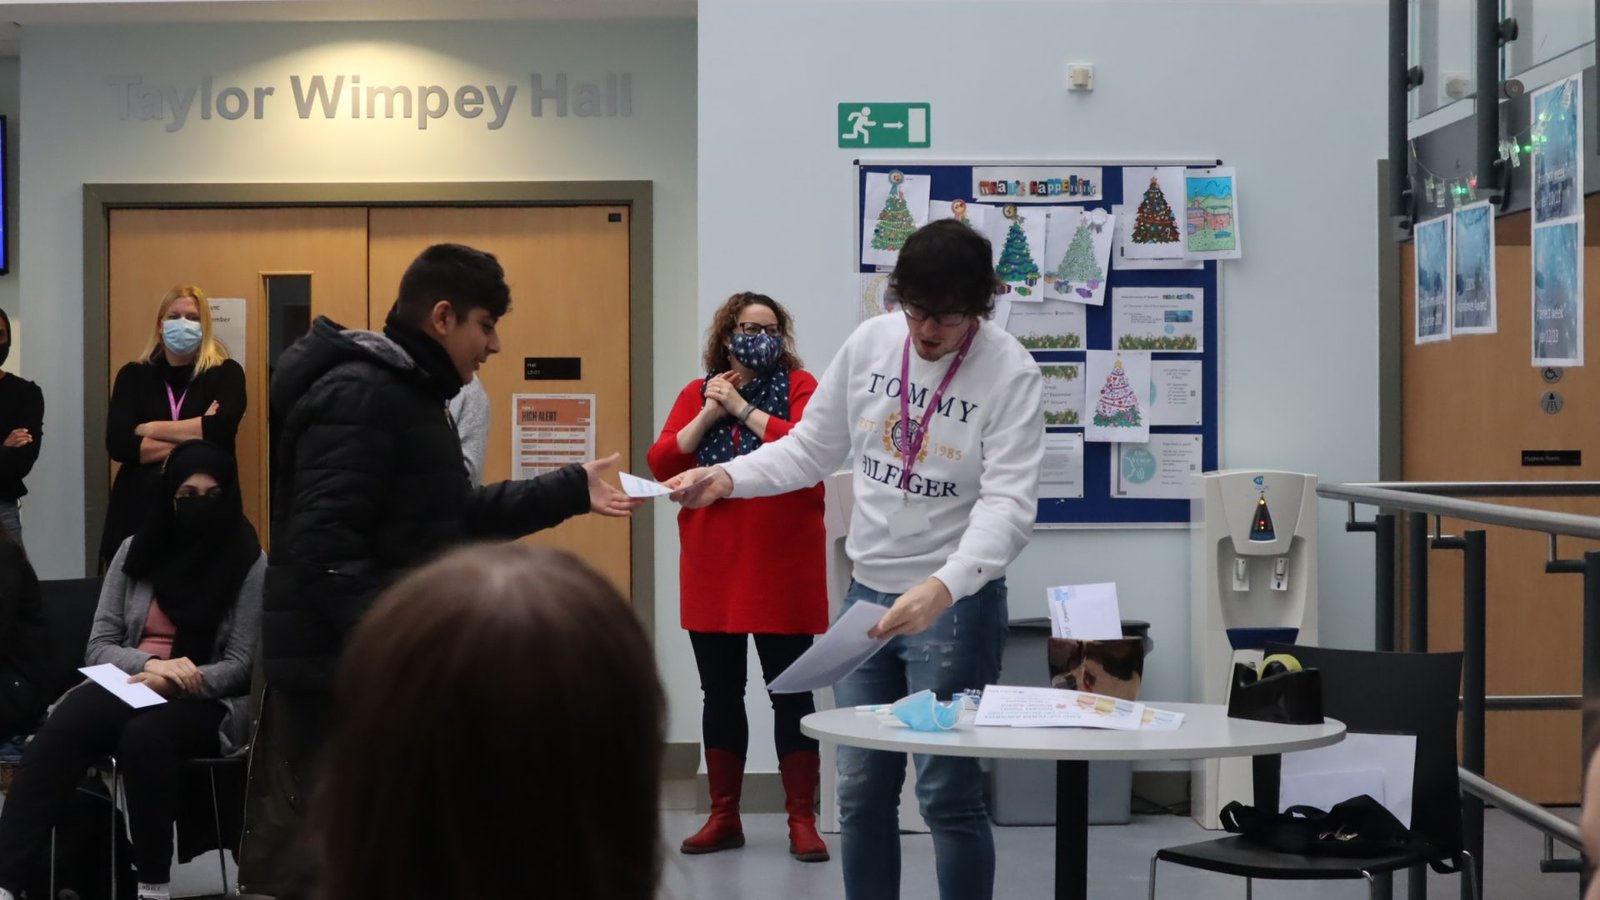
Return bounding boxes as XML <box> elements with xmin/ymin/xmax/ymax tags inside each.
<box><xmin>1278</xmin><ymin>732</ymin><xmax>1416</xmax><ymax>828</ymax></box>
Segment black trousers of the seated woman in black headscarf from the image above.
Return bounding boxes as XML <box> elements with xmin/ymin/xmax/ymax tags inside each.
<box><xmin>0</xmin><ymin>684</ymin><xmax>226</xmax><ymax>894</ymax></box>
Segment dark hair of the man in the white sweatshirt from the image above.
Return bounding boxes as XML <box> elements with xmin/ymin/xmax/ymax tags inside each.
<box><xmin>890</xmin><ymin>219</ymin><xmax>1003</xmax><ymax>319</ymax></box>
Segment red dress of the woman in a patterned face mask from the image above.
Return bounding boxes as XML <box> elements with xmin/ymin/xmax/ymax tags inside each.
<box><xmin>648</xmin><ymin>368</ymin><xmax>827</xmax><ymax>634</ymax></box>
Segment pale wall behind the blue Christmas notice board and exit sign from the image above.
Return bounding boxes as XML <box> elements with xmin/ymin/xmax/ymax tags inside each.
<box><xmin>700</xmin><ymin>0</ymin><xmax>1386</xmax><ymax>768</ymax></box>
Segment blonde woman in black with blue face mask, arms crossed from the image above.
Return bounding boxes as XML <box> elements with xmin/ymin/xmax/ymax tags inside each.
<box><xmin>99</xmin><ymin>285</ymin><xmax>245</xmax><ymax>570</ymax></box>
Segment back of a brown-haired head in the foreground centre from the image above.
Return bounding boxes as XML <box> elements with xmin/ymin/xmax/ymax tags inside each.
<box><xmin>315</xmin><ymin>544</ymin><xmax>666</xmax><ymax>900</ymax></box>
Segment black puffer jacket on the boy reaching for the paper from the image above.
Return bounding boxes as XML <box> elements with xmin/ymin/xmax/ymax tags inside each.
<box><xmin>262</xmin><ymin>317</ymin><xmax>589</xmax><ymax>693</ymax></box>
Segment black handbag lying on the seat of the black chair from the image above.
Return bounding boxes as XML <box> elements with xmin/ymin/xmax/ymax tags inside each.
<box><xmin>1219</xmin><ymin>794</ymin><xmax>1454</xmax><ymax>873</ymax></box>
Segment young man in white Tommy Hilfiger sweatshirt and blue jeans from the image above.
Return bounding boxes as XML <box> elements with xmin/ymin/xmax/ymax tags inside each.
<box><xmin>667</xmin><ymin>219</ymin><xmax>1045</xmax><ymax>900</ymax></box>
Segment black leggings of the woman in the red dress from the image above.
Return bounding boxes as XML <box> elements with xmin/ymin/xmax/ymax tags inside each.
<box><xmin>690</xmin><ymin>631</ymin><xmax>816</xmax><ymax>757</ymax></box>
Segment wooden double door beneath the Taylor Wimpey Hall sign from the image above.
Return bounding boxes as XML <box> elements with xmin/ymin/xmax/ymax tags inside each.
<box><xmin>107</xmin><ymin>207</ymin><xmax>632</xmax><ymax>596</ymax></box>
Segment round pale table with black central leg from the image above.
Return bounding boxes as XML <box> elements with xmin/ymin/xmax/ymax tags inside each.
<box><xmin>800</xmin><ymin>703</ymin><xmax>1344</xmax><ymax>900</ymax></box>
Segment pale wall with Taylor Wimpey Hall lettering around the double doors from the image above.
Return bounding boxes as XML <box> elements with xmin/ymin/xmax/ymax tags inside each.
<box><xmin>15</xmin><ymin>21</ymin><xmax>699</xmax><ymax>740</ymax></box>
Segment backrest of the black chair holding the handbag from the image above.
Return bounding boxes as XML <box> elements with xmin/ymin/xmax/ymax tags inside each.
<box><xmin>1256</xmin><ymin>644</ymin><xmax>1461</xmax><ymax>854</ymax></box>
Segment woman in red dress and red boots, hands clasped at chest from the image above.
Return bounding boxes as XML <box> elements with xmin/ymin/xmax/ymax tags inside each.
<box><xmin>650</xmin><ymin>293</ymin><xmax>827</xmax><ymax>862</ymax></box>
